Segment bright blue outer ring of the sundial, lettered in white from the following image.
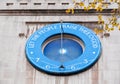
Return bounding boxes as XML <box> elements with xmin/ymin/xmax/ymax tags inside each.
<box><xmin>26</xmin><ymin>23</ymin><xmax>101</xmax><ymax>74</ymax></box>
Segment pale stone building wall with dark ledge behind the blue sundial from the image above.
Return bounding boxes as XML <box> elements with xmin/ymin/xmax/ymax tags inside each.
<box><xmin>0</xmin><ymin>0</ymin><xmax>120</xmax><ymax>84</ymax></box>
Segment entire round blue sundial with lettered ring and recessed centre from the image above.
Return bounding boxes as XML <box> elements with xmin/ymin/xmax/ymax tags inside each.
<box><xmin>26</xmin><ymin>23</ymin><xmax>101</xmax><ymax>75</ymax></box>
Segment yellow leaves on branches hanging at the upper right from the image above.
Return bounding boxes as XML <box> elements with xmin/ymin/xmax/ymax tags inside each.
<box><xmin>66</xmin><ymin>0</ymin><xmax>120</xmax><ymax>34</ymax></box>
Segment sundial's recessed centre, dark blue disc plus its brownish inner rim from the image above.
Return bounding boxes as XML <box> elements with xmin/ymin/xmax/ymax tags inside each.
<box><xmin>43</xmin><ymin>33</ymin><xmax>84</xmax><ymax>63</ymax></box>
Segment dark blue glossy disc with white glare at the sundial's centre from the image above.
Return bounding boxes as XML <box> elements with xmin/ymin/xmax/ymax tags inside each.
<box><xmin>44</xmin><ymin>38</ymin><xmax>83</xmax><ymax>63</ymax></box>
